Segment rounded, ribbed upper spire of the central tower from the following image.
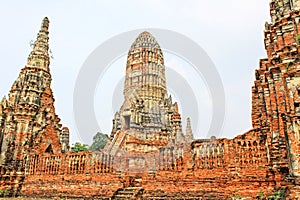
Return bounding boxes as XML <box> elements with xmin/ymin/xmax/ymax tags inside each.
<box><xmin>124</xmin><ymin>31</ymin><xmax>167</xmax><ymax>99</ymax></box>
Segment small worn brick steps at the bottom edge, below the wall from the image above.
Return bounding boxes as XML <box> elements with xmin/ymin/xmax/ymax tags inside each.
<box><xmin>111</xmin><ymin>187</ymin><xmax>144</xmax><ymax>200</ymax></box>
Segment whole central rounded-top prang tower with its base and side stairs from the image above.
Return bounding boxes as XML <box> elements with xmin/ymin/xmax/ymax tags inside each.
<box><xmin>105</xmin><ymin>32</ymin><xmax>193</xmax><ymax>155</ymax></box>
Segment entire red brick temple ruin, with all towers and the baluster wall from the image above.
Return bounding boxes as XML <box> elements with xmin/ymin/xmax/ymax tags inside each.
<box><xmin>0</xmin><ymin>0</ymin><xmax>300</xmax><ymax>200</ymax></box>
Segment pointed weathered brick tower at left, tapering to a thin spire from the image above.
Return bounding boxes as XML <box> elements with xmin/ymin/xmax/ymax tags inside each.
<box><xmin>0</xmin><ymin>17</ymin><xmax>69</xmax><ymax>170</ymax></box>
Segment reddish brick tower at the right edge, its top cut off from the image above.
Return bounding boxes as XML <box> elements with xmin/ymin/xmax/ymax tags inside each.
<box><xmin>252</xmin><ymin>0</ymin><xmax>300</xmax><ymax>176</ymax></box>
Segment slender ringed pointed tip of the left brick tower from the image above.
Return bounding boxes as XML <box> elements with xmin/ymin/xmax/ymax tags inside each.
<box><xmin>26</xmin><ymin>17</ymin><xmax>50</xmax><ymax>71</ymax></box>
